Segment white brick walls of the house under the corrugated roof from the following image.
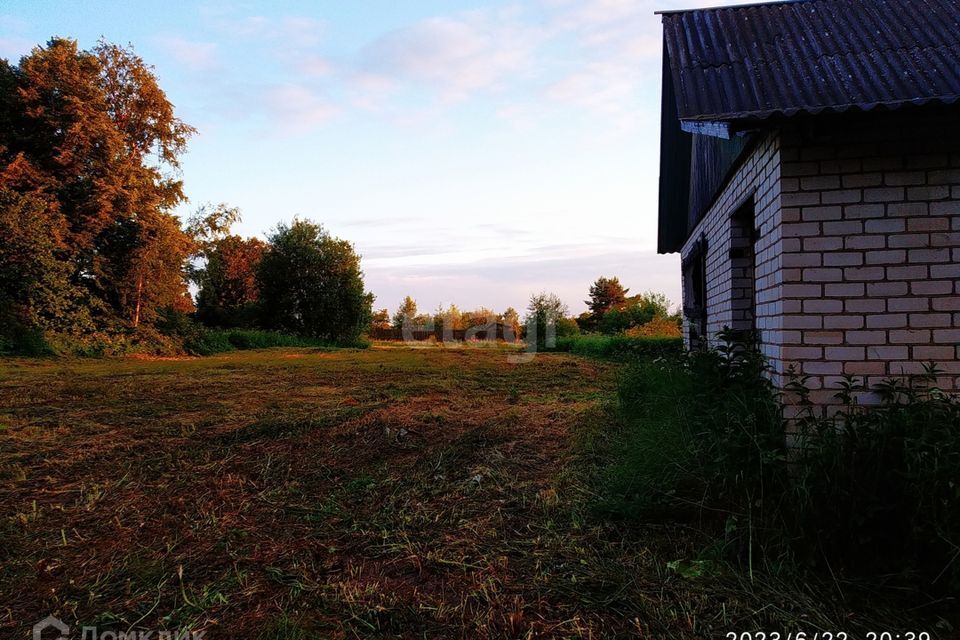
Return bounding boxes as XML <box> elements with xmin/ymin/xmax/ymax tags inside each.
<box><xmin>683</xmin><ymin>111</ymin><xmax>960</xmax><ymax>405</ymax></box>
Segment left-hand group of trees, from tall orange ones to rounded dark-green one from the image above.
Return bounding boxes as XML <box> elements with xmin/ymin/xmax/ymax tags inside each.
<box><xmin>0</xmin><ymin>39</ymin><xmax>373</xmax><ymax>352</ymax></box>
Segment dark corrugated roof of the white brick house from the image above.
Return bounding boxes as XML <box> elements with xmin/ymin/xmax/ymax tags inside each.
<box><xmin>663</xmin><ymin>0</ymin><xmax>960</xmax><ymax>122</ymax></box>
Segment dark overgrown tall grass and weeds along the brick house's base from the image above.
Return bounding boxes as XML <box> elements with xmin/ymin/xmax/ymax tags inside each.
<box><xmin>596</xmin><ymin>330</ymin><xmax>960</xmax><ymax>597</ymax></box>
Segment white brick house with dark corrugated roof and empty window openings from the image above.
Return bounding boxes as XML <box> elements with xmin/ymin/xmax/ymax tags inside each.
<box><xmin>658</xmin><ymin>0</ymin><xmax>960</xmax><ymax>405</ymax></box>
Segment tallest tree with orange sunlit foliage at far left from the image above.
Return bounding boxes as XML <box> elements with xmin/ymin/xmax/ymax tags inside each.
<box><xmin>0</xmin><ymin>38</ymin><xmax>193</xmax><ymax>331</ymax></box>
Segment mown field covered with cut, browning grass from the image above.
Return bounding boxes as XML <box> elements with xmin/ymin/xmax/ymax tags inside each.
<box><xmin>0</xmin><ymin>345</ymin><xmax>916</xmax><ymax>638</ymax></box>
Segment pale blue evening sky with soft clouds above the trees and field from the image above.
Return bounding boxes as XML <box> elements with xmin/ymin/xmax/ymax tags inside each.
<box><xmin>0</xmin><ymin>0</ymin><xmax>760</xmax><ymax>314</ymax></box>
